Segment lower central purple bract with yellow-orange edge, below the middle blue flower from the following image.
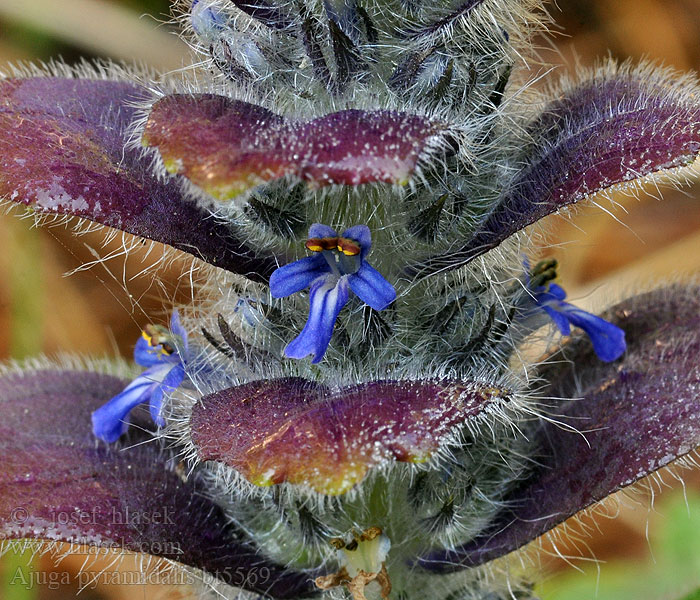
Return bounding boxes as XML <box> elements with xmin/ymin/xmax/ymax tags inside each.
<box><xmin>191</xmin><ymin>379</ymin><xmax>508</xmax><ymax>495</ymax></box>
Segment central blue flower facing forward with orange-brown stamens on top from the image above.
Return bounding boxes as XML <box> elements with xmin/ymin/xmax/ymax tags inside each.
<box><xmin>270</xmin><ymin>223</ymin><xmax>396</xmax><ymax>363</ymax></box>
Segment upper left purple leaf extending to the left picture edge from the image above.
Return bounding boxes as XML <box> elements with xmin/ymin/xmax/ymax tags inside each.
<box><xmin>0</xmin><ymin>77</ymin><xmax>275</xmax><ymax>280</ymax></box>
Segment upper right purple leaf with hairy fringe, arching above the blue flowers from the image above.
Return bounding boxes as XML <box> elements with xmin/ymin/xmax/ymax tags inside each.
<box><xmin>411</xmin><ymin>65</ymin><xmax>700</xmax><ymax>275</ymax></box>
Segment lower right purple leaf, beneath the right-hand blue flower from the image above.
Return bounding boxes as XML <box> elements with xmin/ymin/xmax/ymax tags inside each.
<box><xmin>421</xmin><ymin>286</ymin><xmax>700</xmax><ymax>571</ymax></box>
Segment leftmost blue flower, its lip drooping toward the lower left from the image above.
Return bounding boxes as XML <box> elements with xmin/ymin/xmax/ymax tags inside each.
<box><xmin>92</xmin><ymin>311</ymin><xmax>188</xmax><ymax>443</ymax></box>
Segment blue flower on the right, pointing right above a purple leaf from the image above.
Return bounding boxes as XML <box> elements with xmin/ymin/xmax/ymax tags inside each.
<box><xmin>531</xmin><ymin>283</ymin><xmax>627</xmax><ymax>362</ymax></box>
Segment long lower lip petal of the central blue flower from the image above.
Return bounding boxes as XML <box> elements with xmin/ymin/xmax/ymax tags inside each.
<box><xmin>284</xmin><ymin>275</ymin><xmax>349</xmax><ymax>364</ymax></box>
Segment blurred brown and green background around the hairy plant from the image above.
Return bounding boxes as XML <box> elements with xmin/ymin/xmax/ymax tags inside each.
<box><xmin>0</xmin><ymin>0</ymin><xmax>700</xmax><ymax>600</ymax></box>
